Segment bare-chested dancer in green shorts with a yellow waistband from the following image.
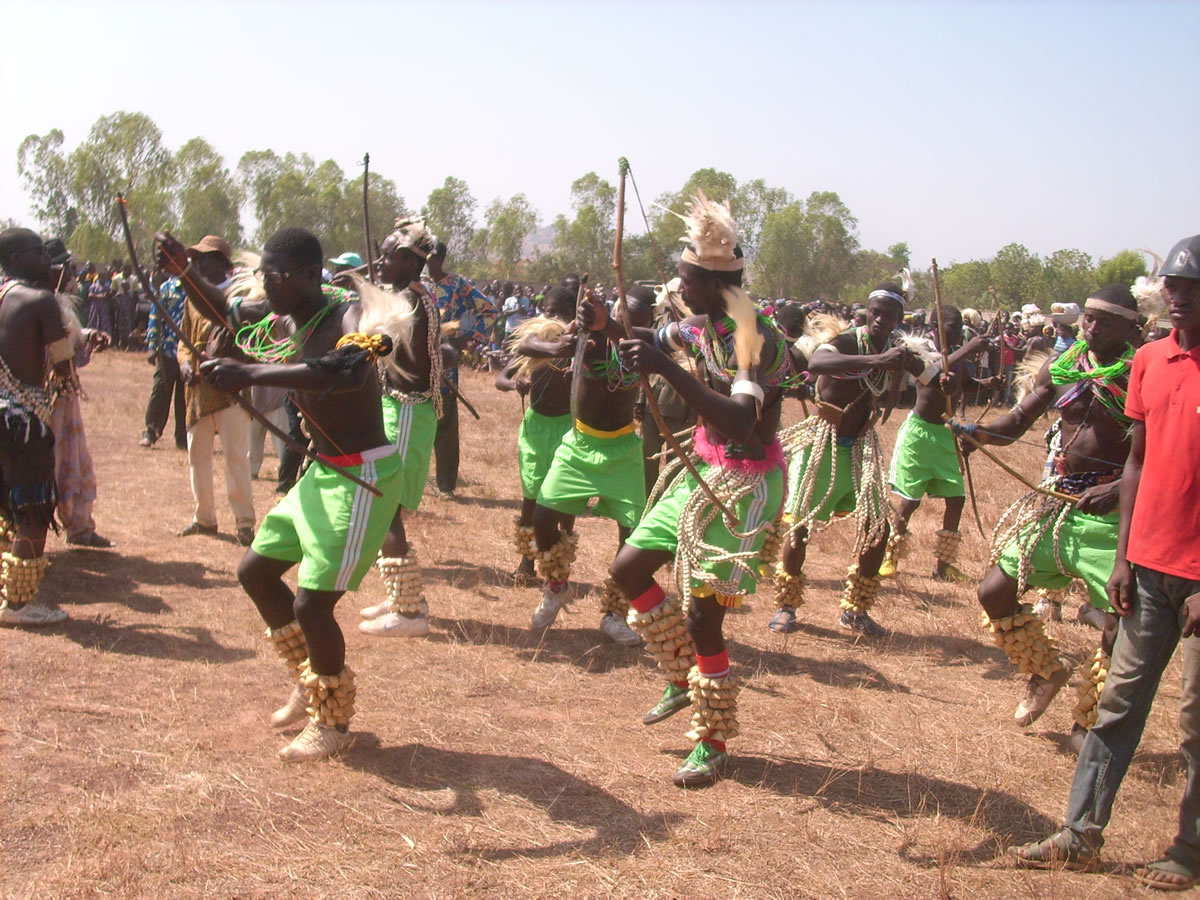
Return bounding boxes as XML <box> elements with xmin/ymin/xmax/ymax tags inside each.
<box><xmin>530</xmin><ymin>288</ymin><xmax>654</xmax><ymax>647</ymax></box>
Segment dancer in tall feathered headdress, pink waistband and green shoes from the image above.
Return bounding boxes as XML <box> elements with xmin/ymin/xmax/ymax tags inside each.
<box><xmin>604</xmin><ymin>192</ymin><xmax>792</xmax><ymax>787</ymax></box>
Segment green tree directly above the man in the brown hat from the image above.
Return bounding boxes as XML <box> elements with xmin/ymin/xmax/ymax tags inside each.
<box><xmin>175</xmin><ymin>138</ymin><xmax>246</xmax><ymax>247</ymax></box>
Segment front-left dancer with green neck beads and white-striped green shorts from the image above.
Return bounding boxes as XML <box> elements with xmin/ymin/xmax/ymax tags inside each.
<box><xmin>156</xmin><ymin>228</ymin><xmax>402</xmax><ymax>762</ymax></box>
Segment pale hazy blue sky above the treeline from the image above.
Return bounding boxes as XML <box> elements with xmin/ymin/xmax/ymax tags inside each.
<box><xmin>0</xmin><ymin>0</ymin><xmax>1200</xmax><ymax>266</ymax></box>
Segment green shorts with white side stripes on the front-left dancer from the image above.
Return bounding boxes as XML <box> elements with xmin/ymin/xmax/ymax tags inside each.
<box><xmin>250</xmin><ymin>444</ymin><xmax>404</xmax><ymax>600</ymax></box>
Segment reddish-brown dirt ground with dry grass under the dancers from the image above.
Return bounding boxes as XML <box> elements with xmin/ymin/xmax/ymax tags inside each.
<box><xmin>0</xmin><ymin>352</ymin><xmax>1184</xmax><ymax>899</ymax></box>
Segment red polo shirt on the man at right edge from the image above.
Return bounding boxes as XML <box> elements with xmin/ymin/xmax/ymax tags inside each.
<box><xmin>1126</xmin><ymin>330</ymin><xmax>1200</xmax><ymax>581</ymax></box>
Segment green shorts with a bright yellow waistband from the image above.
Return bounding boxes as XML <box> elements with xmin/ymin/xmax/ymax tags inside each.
<box><xmin>538</xmin><ymin>428</ymin><xmax>646</xmax><ymax>528</ymax></box>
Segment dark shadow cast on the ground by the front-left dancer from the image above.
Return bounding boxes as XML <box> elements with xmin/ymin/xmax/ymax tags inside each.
<box><xmin>344</xmin><ymin>733</ymin><xmax>683</xmax><ymax>860</ymax></box>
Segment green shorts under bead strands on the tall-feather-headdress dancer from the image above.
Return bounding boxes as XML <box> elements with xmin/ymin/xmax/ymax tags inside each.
<box><xmin>626</xmin><ymin>463</ymin><xmax>784</xmax><ymax>594</ymax></box>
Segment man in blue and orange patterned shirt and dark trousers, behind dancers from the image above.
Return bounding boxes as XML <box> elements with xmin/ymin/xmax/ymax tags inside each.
<box><xmin>425</xmin><ymin>241</ymin><xmax>499</xmax><ymax>499</ymax></box>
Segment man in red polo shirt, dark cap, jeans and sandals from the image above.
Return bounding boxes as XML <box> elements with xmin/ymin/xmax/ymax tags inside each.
<box><xmin>1009</xmin><ymin>234</ymin><xmax>1200</xmax><ymax>890</ymax></box>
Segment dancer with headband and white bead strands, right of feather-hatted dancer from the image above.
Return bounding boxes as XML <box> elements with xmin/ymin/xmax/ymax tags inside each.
<box><xmin>768</xmin><ymin>282</ymin><xmax>925</xmax><ymax>637</ymax></box>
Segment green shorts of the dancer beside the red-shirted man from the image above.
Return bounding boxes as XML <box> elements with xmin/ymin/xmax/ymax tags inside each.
<box><xmin>996</xmin><ymin>511</ymin><xmax>1121</xmax><ymax>612</ymax></box>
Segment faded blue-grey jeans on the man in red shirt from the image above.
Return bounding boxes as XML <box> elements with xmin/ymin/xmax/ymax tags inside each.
<box><xmin>1063</xmin><ymin>568</ymin><xmax>1200</xmax><ymax>870</ymax></box>
